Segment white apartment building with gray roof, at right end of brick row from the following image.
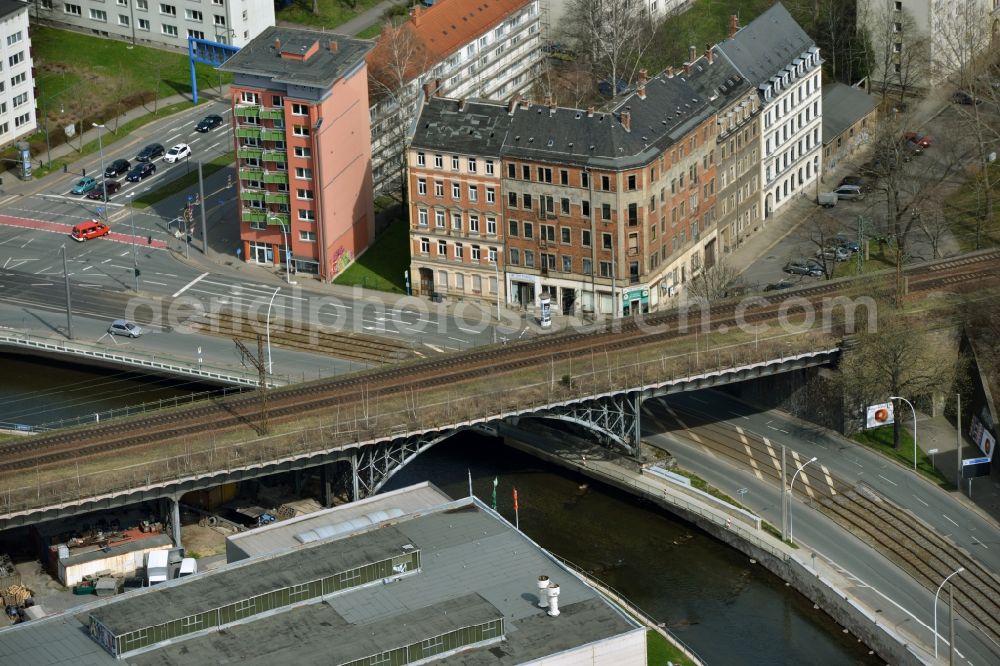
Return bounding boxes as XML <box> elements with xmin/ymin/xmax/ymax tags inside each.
<box><xmin>719</xmin><ymin>3</ymin><xmax>823</xmax><ymax>220</ymax></box>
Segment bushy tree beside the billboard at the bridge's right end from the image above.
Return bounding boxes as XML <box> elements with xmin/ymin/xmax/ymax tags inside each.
<box><xmin>839</xmin><ymin>303</ymin><xmax>964</xmax><ymax>449</ymax></box>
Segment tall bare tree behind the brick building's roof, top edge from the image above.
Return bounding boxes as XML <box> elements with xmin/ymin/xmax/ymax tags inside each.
<box><xmin>562</xmin><ymin>0</ymin><xmax>656</xmax><ymax>97</ymax></box>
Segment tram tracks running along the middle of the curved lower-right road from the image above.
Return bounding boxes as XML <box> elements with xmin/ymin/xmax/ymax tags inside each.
<box><xmin>660</xmin><ymin>407</ymin><xmax>1000</xmax><ymax>645</ymax></box>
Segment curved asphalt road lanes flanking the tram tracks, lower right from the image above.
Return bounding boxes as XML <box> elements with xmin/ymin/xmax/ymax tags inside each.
<box><xmin>643</xmin><ymin>391</ymin><xmax>1000</xmax><ymax>665</ymax></box>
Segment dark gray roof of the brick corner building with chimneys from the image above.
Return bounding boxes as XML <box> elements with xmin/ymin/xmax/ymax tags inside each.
<box><xmin>411</xmin><ymin>48</ymin><xmax>749</xmax><ymax>169</ymax></box>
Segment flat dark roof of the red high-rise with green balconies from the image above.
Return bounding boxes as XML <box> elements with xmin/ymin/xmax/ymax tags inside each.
<box><xmin>219</xmin><ymin>26</ymin><xmax>375</xmax><ymax>88</ymax></box>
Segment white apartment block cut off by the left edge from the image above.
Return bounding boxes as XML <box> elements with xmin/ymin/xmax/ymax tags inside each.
<box><xmin>0</xmin><ymin>0</ymin><xmax>38</xmax><ymax>146</ymax></box>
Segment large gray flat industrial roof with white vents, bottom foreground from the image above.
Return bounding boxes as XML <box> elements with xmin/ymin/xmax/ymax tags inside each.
<box><xmin>0</xmin><ymin>486</ymin><xmax>644</xmax><ymax>666</ymax></box>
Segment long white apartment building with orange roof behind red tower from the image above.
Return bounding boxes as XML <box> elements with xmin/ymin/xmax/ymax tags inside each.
<box><xmin>368</xmin><ymin>0</ymin><xmax>545</xmax><ymax>192</ymax></box>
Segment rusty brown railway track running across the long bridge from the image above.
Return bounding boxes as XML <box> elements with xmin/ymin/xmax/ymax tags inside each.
<box><xmin>0</xmin><ymin>251</ymin><xmax>1000</xmax><ymax>471</ymax></box>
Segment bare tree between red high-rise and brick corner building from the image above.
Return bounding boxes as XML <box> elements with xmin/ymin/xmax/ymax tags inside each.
<box><xmin>368</xmin><ymin>21</ymin><xmax>431</xmax><ymax>203</ymax></box>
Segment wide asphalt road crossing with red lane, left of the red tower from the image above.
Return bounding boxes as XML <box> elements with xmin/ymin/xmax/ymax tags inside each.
<box><xmin>0</xmin><ymin>102</ymin><xmax>525</xmax><ymax>353</ymax></box>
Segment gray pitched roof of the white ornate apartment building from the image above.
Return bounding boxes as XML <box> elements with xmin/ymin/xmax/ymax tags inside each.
<box><xmin>719</xmin><ymin>2</ymin><xmax>814</xmax><ymax>86</ymax></box>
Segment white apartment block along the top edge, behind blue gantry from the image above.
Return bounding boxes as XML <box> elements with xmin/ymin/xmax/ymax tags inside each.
<box><xmin>31</xmin><ymin>0</ymin><xmax>274</xmax><ymax>50</ymax></box>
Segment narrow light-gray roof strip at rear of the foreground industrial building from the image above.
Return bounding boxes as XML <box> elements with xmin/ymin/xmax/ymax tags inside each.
<box><xmin>226</xmin><ymin>481</ymin><xmax>451</xmax><ymax>562</ymax></box>
